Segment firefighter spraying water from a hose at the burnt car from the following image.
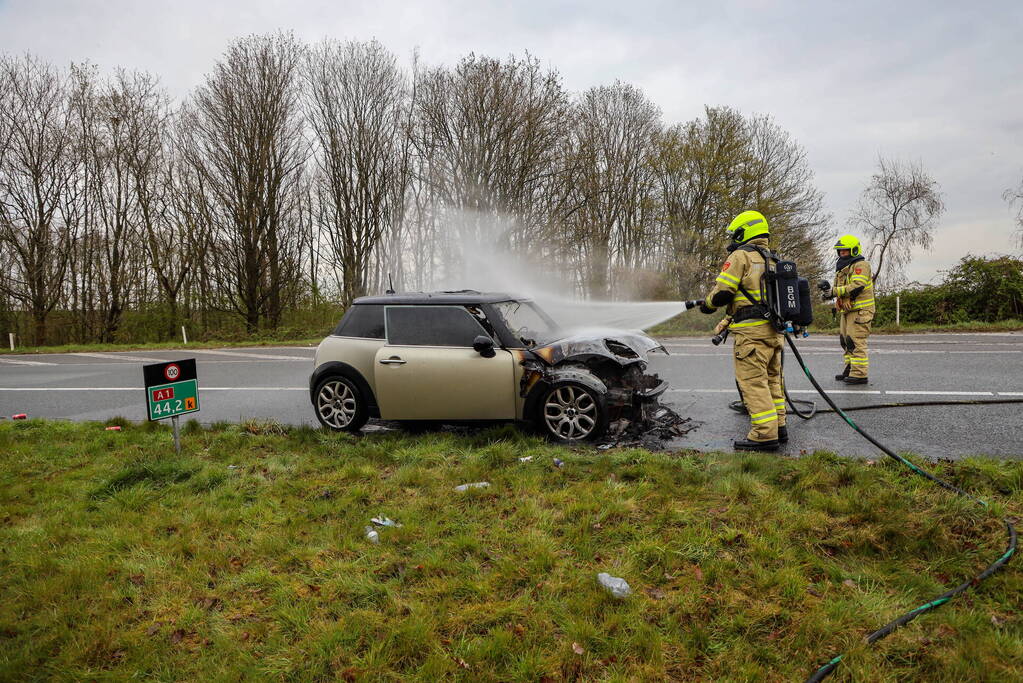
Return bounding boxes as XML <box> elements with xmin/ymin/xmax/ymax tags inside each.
<box><xmin>700</xmin><ymin>211</ymin><xmax>789</xmax><ymax>451</ymax></box>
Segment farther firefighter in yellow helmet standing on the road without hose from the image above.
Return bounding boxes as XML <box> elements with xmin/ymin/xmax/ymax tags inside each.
<box><xmin>817</xmin><ymin>235</ymin><xmax>874</xmax><ymax>384</ymax></box>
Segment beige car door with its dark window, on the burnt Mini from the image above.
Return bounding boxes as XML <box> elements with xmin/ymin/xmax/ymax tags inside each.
<box><xmin>373</xmin><ymin>306</ymin><xmax>516</xmax><ymax>420</ymax></box>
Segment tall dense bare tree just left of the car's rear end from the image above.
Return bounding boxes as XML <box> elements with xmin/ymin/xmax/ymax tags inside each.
<box><xmin>180</xmin><ymin>34</ymin><xmax>306</xmax><ymax>332</ymax></box>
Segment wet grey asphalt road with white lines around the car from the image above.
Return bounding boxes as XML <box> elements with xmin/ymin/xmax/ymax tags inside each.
<box><xmin>0</xmin><ymin>332</ymin><xmax>1023</xmax><ymax>458</ymax></box>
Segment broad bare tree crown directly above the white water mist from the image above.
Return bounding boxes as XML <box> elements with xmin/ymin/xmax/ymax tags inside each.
<box><xmin>414</xmin><ymin>54</ymin><xmax>571</xmax><ymax>268</ymax></box>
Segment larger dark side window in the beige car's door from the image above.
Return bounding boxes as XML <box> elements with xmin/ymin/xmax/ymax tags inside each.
<box><xmin>387</xmin><ymin>306</ymin><xmax>487</xmax><ymax>347</ymax></box>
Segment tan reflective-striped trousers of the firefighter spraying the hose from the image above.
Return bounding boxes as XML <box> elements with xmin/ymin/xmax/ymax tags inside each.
<box><xmin>733</xmin><ymin>334</ymin><xmax>785</xmax><ymax>441</ymax></box>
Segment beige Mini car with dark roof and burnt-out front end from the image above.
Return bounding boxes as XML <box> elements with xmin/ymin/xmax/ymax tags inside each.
<box><xmin>309</xmin><ymin>290</ymin><xmax>667</xmax><ymax>443</ymax></box>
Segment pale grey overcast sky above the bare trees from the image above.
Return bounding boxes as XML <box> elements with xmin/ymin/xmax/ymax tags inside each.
<box><xmin>0</xmin><ymin>0</ymin><xmax>1023</xmax><ymax>281</ymax></box>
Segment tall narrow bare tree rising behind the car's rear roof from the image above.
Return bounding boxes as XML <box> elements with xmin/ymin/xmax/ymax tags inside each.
<box><xmin>306</xmin><ymin>40</ymin><xmax>409</xmax><ymax>306</ymax></box>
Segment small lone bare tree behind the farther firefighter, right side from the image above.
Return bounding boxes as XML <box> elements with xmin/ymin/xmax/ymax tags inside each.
<box><xmin>849</xmin><ymin>156</ymin><xmax>945</xmax><ymax>290</ymax></box>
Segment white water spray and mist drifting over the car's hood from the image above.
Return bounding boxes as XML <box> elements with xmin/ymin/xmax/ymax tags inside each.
<box><xmin>427</xmin><ymin>211</ymin><xmax>684</xmax><ymax>332</ymax></box>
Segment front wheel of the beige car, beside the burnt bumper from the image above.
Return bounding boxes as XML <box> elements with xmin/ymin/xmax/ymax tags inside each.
<box><xmin>537</xmin><ymin>381</ymin><xmax>608</xmax><ymax>444</ymax></box>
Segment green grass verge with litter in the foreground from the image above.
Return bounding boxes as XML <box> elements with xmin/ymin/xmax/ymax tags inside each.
<box><xmin>0</xmin><ymin>420</ymin><xmax>1023</xmax><ymax>681</ymax></box>
